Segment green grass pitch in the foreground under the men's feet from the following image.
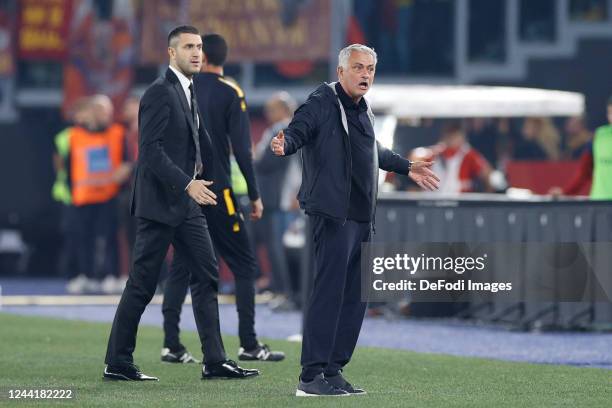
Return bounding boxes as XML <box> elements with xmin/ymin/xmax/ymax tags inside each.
<box><xmin>0</xmin><ymin>314</ymin><xmax>612</xmax><ymax>408</ymax></box>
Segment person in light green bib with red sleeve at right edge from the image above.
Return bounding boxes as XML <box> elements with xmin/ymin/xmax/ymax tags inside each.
<box><xmin>549</xmin><ymin>96</ymin><xmax>612</xmax><ymax>200</ymax></box>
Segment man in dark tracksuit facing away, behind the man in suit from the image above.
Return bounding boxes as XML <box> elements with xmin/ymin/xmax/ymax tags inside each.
<box><xmin>162</xmin><ymin>34</ymin><xmax>284</xmax><ymax>363</ymax></box>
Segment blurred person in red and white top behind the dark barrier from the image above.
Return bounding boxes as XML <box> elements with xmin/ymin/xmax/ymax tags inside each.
<box><xmin>432</xmin><ymin>121</ymin><xmax>492</xmax><ymax>194</ymax></box>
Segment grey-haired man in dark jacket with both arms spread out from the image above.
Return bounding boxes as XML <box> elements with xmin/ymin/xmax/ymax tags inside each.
<box><xmin>270</xmin><ymin>44</ymin><xmax>439</xmax><ymax>396</ymax></box>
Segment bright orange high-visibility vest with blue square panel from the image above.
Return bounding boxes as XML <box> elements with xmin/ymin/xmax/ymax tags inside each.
<box><xmin>70</xmin><ymin>125</ymin><xmax>124</xmax><ymax>206</ymax></box>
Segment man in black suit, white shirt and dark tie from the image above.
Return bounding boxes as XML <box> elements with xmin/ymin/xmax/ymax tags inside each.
<box><xmin>104</xmin><ymin>26</ymin><xmax>259</xmax><ymax>381</ymax></box>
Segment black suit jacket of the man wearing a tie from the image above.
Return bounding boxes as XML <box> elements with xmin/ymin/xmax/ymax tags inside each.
<box><xmin>131</xmin><ymin>68</ymin><xmax>214</xmax><ymax>226</ymax></box>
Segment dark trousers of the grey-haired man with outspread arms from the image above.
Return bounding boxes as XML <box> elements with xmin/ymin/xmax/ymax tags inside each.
<box><xmin>301</xmin><ymin>215</ymin><xmax>371</xmax><ymax>381</ymax></box>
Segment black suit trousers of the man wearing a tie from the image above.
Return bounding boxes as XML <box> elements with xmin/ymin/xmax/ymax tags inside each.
<box><xmin>105</xmin><ymin>200</ymin><xmax>226</xmax><ymax>366</ymax></box>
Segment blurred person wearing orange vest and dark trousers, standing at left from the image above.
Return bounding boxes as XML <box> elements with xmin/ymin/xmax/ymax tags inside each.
<box><xmin>69</xmin><ymin>95</ymin><xmax>131</xmax><ymax>292</ymax></box>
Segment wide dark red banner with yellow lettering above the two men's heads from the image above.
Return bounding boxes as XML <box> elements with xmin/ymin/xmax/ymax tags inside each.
<box><xmin>141</xmin><ymin>0</ymin><xmax>331</xmax><ymax>64</ymax></box>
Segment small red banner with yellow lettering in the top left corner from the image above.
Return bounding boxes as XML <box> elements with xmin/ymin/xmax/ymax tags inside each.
<box><xmin>17</xmin><ymin>0</ymin><xmax>72</xmax><ymax>60</ymax></box>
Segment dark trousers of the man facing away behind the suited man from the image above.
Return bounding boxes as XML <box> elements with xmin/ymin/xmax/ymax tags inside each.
<box><xmin>162</xmin><ymin>190</ymin><xmax>257</xmax><ymax>351</ymax></box>
